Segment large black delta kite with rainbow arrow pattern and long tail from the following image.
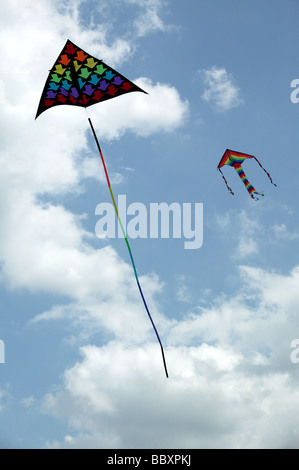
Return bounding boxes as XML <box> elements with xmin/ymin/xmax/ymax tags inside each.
<box><xmin>35</xmin><ymin>40</ymin><xmax>168</xmax><ymax>377</ymax></box>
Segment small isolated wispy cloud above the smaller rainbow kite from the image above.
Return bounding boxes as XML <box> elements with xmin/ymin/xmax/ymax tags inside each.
<box><xmin>200</xmin><ymin>66</ymin><xmax>243</xmax><ymax>111</ymax></box>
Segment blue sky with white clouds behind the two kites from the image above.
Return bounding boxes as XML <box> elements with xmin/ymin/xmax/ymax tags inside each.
<box><xmin>0</xmin><ymin>0</ymin><xmax>299</xmax><ymax>449</ymax></box>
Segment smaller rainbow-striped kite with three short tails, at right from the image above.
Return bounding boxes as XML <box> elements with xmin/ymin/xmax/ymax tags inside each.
<box><xmin>217</xmin><ymin>149</ymin><xmax>276</xmax><ymax>200</ymax></box>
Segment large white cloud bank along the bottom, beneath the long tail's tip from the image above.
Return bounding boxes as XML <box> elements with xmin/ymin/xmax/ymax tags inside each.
<box><xmin>39</xmin><ymin>266</ymin><xmax>299</xmax><ymax>448</ymax></box>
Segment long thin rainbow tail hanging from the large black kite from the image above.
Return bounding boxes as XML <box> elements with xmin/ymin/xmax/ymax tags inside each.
<box><xmin>88</xmin><ymin>118</ymin><xmax>168</xmax><ymax>378</ymax></box>
